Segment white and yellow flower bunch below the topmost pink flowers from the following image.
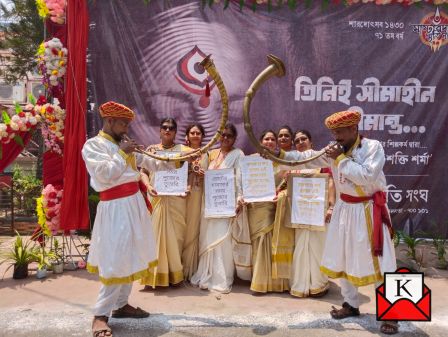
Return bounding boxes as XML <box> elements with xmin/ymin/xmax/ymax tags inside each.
<box><xmin>37</xmin><ymin>37</ymin><xmax>68</xmax><ymax>90</ymax></box>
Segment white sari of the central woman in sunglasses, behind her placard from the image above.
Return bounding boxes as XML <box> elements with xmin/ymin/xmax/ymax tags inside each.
<box><xmin>191</xmin><ymin>149</ymin><xmax>251</xmax><ymax>293</ymax></box>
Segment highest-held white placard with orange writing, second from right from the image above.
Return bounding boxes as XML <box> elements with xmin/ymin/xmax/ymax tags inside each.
<box><xmin>240</xmin><ymin>156</ymin><xmax>275</xmax><ymax>202</ymax></box>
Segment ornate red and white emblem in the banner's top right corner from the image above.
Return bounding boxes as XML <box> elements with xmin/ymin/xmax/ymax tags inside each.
<box><xmin>411</xmin><ymin>7</ymin><xmax>448</xmax><ymax>52</ymax></box>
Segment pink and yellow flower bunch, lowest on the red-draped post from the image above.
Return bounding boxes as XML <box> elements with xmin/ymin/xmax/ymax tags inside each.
<box><xmin>36</xmin><ymin>184</ymin><xmax>63</xmax><ymax>236</ymax></box>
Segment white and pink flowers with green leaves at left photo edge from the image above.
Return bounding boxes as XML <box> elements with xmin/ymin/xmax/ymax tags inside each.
<box><xmin>0</xmin><ymin>103</ymin><xmax>41</xmax><ymax>158</ymax></box>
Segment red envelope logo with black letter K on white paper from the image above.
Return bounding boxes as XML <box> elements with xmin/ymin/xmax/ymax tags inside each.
<box><xmin>376</xmin><ymin>268</ymin><xmax>431</xmax><ymax>321</ymax></box>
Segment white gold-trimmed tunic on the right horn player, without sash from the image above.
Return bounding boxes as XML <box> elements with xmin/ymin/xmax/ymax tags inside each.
<box><xmin>285</xmin><ymin>138</ymin><xmax>396</xmax><ymax>286</ymax></box>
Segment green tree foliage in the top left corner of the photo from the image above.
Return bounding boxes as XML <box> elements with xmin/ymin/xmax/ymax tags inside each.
<box><xmin>0</xmin><ymin>0</ymin><xmax>44</xmax><ymax>84</ymax></box>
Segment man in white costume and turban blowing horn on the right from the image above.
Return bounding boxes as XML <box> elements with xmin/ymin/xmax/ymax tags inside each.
<box><xmin>272</xmin><ymin>111</ymin><xmax>398</xmax><ymax>334</ymax></box>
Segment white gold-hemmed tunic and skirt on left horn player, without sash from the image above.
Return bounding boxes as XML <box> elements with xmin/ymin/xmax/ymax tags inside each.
<box><xmin>82</xmin><ymin>135</ymin><xmax>173</xmax><ymax>285</ymax></box>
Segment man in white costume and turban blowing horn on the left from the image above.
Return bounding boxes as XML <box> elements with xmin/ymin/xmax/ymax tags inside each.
<box><xmin>82</xmin><ymin>102</ymin><xmax>173</xmax><ymax>337</ymax></box>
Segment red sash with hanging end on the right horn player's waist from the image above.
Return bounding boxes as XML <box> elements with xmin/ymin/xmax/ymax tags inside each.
<box><xmin>341</xmin><ymin>191</ymin><xmax>393</xmax><ymax>256</ymax></box>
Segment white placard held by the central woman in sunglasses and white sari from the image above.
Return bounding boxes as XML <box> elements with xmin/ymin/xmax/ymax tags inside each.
<box><xmin>204</xmin><ymin>169</ymin><xmax>236</xmax><ymax>218</ymax></box>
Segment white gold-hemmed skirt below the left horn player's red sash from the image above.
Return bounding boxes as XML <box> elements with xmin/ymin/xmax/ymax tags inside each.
<box><xmin>87</xmin><ymin>192</ymin><xmax>157</xmax><ymax>285</ymax></box>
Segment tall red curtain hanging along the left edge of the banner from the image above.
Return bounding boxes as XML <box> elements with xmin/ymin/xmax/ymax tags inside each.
<box><xmin>60</xmin><ymin>0</ymin><xmax>89</xmax><ymax>231</ymax></box>
